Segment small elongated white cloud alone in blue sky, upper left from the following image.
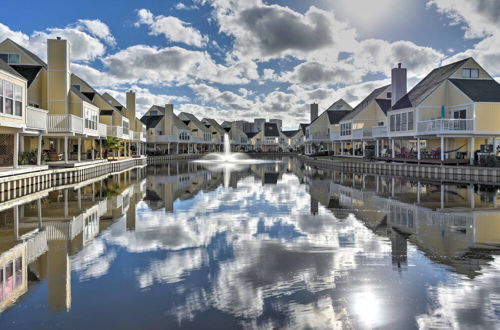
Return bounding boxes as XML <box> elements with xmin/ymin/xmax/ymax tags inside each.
<box><xmin>135</xmin><ymin>9</ymin><xmax>208</xmax><ymax>47</ymax></box>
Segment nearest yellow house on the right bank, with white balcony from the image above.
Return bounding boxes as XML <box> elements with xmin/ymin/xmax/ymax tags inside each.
<box><xmin>387</xmin><ymin>58</ymin><xmax>500</xmax><ymax>163</ymax></box>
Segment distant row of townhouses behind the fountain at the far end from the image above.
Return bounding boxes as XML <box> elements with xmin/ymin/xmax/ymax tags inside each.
<box><xmin>141</xmin><ymin>104</ymin><xmax>305</xmax><ymax>155</ymax></box>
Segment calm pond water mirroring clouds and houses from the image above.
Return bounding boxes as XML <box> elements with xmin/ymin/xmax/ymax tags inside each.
<box><xmin>0</xmin><ymin>158</ymin><xmax>500</xmax><ymax>329</ymax></box>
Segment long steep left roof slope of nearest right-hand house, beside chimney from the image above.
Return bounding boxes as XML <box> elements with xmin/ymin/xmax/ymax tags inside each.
<box><xmin>389</xmin><ymin>58</ymin><xmax>469</xmax><ymax>111</ymax></box>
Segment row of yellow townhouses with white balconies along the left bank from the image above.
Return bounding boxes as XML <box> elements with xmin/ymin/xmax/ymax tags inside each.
<box><xmin>0</xmin><ymin>38</ymin><xmax>146</xmax><ymax>169</ymax></box>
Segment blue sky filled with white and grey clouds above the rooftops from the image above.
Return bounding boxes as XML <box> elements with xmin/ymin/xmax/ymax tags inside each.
<box><xmin>0</xmin><ymin>0</ymin><xmax>500</xmax><ymax>129</ymax></box>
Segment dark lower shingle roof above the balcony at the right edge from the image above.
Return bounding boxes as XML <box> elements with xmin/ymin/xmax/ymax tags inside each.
<box><xmin>450</xmin><ymin>79</ymin><xmax>500</xmax><ymax>102</ymax></box>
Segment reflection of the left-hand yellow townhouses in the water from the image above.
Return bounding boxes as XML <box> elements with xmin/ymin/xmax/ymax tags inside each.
<box><xmin>0</xmin><ymin>168</ymin><xmax>146</xmax><ymax>312</ymax></box>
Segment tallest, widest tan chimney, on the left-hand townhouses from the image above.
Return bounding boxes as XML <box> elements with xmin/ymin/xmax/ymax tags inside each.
<box><xmin>47</xmin><ymin>37</ymin><xmax>70</xmax><ymax>113</ymax></box>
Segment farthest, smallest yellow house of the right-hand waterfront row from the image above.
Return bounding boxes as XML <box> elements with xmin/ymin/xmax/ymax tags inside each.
<box><xmin>305</xmin><ymin>99</ymin><xmax>352</xmax><ymax>154</ymax></box>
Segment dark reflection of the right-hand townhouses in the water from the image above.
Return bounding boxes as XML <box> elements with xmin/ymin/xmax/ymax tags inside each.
<box><xmin>306</xmin><ymin>169</ymin><xmax>500</xmax><ymax>278</ymax></box>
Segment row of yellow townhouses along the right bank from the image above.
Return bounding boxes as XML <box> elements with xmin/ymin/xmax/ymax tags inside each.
<box><xmin>304</xmin><ymin>58</ymin><xmax>500</xmax><ymax>164</ymax></box>
